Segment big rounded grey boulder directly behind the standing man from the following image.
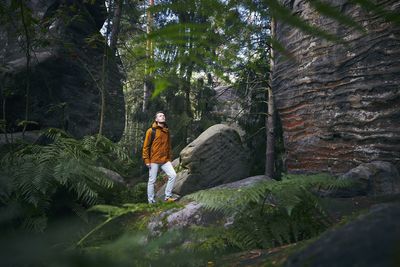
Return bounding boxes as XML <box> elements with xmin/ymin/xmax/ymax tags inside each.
<box><xmin>159</xmin><ymin>124</ymin><xmax>249</xmax><ymax>195</ymax></box>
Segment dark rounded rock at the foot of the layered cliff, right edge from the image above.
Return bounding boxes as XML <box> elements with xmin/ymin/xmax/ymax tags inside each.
<box><xmin>329</xmin><ymin>161</ymin><xmax>400</xmax><ymax>197</ymax></box>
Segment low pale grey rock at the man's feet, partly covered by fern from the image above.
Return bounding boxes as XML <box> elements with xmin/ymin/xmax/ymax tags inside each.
<box><xmin>148</xmin><ymin>175</ymin><xmax>273</xmax><ymax>235</ymax></box>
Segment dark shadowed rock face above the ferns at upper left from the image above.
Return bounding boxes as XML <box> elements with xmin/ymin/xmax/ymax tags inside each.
<box><xmin>0</xmin><ymin>0</ymin><xmax>125</xmax><ymax>140</ymax></box>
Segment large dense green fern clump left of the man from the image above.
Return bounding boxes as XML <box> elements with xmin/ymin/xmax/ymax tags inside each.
<box><xmin>0</xmin><ymin>129</ymin><xmax>134</xmax><ymax>230</ymax></box>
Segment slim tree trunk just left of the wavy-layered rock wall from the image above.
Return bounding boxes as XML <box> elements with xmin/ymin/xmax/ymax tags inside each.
<box><xmin>265</xmin><ymin>18</ymin><xmax>275</xmax><ymax>178</ymax></box>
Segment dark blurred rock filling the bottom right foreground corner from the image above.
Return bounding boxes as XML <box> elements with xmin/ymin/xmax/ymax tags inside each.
<box><xmin>284</xmin><ymin>202</ymin><xmax>400</xmax><ymax>267</ymax></box>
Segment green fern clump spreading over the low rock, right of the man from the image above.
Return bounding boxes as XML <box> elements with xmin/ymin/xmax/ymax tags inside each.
<box><xmin>187</xmin><ymin>174</ymin><xmax>349</xmax><ymax>249</ymax></box>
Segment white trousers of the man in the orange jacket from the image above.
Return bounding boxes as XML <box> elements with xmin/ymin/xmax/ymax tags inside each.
<box><xmin>147</xmin><ymin>161</ymin><xmax>176</xmax><ymax>203</ymax></box>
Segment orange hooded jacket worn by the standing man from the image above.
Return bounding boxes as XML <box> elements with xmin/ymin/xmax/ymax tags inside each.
<box><xmin>142</xmin><ymin>122</ymin><xmax>172</xmax><ymax>164</ymax></box>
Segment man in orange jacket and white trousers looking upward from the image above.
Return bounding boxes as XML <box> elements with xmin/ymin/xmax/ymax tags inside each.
<box><xmin>142</xmin><ymin>111</ymin><xmax>176</xmax><ymax>204</ymax></box>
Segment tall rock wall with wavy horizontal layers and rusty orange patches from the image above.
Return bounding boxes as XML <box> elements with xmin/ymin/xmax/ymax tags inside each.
<box><xmin>272</xmin><ymin>0</ymin><xmax>400</xmax><ymax>174</ymax></box>
